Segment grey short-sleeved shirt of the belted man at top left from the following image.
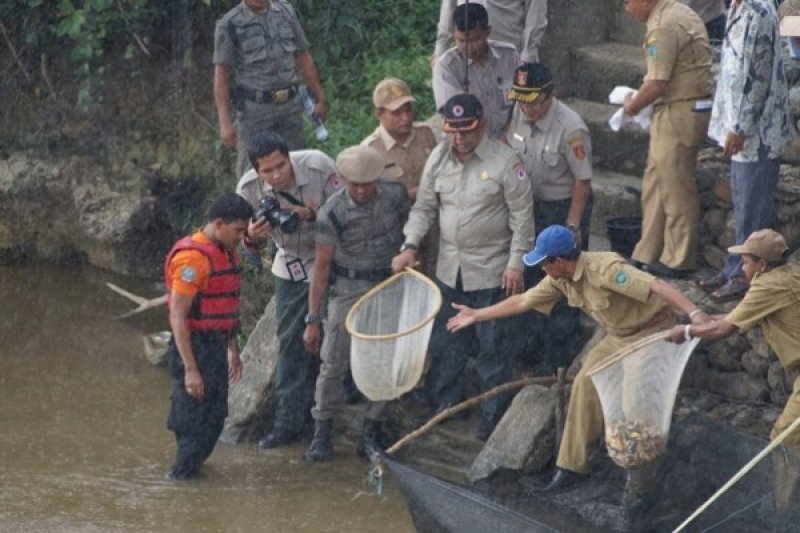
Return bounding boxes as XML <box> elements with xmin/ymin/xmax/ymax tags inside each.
<box><xmin>214</xmin><ymin>0</ymin><xmax>308</xmax><ymax>90</ymax></box>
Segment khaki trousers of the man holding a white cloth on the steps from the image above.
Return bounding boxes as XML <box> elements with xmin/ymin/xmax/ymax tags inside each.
<box><xmin>633</xmin><ymin>101</ymin><xmax>710</xmax><ymax>269</ymax></box>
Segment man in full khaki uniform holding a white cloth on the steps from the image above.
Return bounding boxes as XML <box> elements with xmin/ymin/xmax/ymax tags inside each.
<box><xmin>624</xmin><ymin>0</ymin><xmax>713</xmax><ymax>278</ymax></box>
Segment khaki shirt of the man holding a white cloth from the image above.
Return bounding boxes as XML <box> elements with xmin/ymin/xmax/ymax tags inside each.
<box><xmin>644</xmin><ymin>0</ymin><xmax>713</xmax><ymax>103</ymax></box>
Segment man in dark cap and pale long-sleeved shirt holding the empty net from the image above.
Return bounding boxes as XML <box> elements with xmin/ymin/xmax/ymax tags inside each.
<box><xmin>392</xmin><ymin>94</ymin><xmax>534</xmax><ymax>440</ymax></box>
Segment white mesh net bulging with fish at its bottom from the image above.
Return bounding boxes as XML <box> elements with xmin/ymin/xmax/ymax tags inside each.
<box><xmin>589</xmin><ymin>333</ymin><xmax>700</xmax><ymax>468</ymax></box>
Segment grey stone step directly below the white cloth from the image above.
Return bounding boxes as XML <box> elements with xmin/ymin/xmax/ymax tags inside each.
<box><xmin>563</xmin><ymin>98</ymin><xmax>650</xmax><ymax>176</ymax></box>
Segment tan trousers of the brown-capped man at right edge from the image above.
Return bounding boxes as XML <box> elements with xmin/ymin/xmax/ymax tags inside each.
<box><xmin>769</xmin><ymin>377</ymin><xmax>800</xmax><ymax>512</ymax></box>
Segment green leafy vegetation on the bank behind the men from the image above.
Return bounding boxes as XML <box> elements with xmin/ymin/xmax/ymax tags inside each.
<box><xmin>0</xmin><ymin>0</ymin><xmax>439</xmax><ymax>150</ymax></box>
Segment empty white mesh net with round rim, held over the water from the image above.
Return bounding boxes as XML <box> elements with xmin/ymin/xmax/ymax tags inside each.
<box><xmin>345</xmin><ymin>270</ymin><xmax>442</xmax><ymax>401</ymax></box>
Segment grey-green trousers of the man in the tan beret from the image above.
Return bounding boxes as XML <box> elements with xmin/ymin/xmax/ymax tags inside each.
<box><xmin>311</xmin><ymin>277</ymin><xmax>386</xmax><ymax>420</ymax></box>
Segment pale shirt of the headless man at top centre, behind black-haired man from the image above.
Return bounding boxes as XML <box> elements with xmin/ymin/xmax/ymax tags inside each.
<box><xmin>434</xmin><ymin>0</ymin><xmax>548</xmax><ymax>63</ymax></box>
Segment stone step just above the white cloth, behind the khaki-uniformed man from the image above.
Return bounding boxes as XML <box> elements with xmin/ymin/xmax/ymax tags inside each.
<box><xmin>572</xmin><ymin>42</ymin><xmax>646</xmax><ymax>102</ymax></box>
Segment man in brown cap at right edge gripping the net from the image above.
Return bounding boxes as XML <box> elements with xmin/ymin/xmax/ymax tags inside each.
<box><xmin>668</xmin><ymin>229</ymin><xmax>800</xmax><ymax>512</ymax></box>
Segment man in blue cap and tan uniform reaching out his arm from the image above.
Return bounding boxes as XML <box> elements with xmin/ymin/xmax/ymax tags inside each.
<box><xmin>447</xmin><ymin>225</ymin><xmax>710</xmax><ymax>492</ymax></box>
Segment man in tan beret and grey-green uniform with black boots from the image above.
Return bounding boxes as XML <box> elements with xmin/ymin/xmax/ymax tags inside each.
<box><xmin>303</xmin><ymin>146</ymin><xmax>411</xmax><ymax>462</ymax></box>
